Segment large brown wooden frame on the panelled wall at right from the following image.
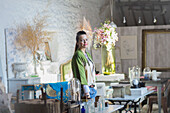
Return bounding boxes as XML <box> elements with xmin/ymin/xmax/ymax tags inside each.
<box><xmin>142</xmin><ymin>29</ymin><xmax>170</xmax><ymax>71</ymax></box>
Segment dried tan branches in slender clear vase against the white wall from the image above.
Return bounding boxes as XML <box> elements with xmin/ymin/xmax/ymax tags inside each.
<box><xmin>15</xmin><ymin>14</ymin><xmax>52</xmax><ymax>74</ymax></box>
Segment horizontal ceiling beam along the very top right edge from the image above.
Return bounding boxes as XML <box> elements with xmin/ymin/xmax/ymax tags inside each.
<box><xmin>117</xmin><ymin>1</ymin><xmax>170</xmax><ymax>6</ymax></box>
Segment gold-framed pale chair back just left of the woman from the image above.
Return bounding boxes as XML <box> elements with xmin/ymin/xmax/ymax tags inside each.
<box><xmin>60</xmin><ymin>60</ymin><xmax>73</xmax><ymax>82</ymax></box>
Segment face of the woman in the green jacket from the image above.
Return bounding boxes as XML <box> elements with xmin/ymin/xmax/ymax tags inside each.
<box><xmin>77</xmin><ymin>34</ymin><xmax>88</xmax><ymax>49</ymax></box>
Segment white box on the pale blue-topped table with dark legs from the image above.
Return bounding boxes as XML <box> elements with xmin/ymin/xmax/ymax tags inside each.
<box><xmin>130</xmin><ymin>87</ymin><xmax>147</xmax><ymax>96</ymax></box>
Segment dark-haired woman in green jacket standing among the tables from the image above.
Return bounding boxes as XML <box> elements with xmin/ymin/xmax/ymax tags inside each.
<box><xmin>72</xmin><ymin>31</ymin><xmax>97</xmax><ymax>98</ymax></box>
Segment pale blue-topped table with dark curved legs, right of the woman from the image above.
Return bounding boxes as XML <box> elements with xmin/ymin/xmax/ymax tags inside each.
<box><xmin>106</xmin><ymin>91</ymin><xmax>154</xmax><ymax>113</ymax></box>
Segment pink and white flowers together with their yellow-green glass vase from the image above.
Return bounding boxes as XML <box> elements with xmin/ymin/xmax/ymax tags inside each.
<box><xmin>93</xmin><ymin>21</ymin><xmax>118</xmax><ymax>74</ymax></box>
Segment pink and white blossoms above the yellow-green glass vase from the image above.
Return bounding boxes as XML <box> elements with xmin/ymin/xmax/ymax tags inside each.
<box><xmin>94</xmin><ymin>21</ymin><xmax>118</xmax><ymax>51</ymax></box>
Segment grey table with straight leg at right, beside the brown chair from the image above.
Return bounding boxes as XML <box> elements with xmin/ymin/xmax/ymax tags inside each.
<box><xmin>141</xmin><ymin>79</ymin><xmax>168</xmax><ymax>113</ymax></box>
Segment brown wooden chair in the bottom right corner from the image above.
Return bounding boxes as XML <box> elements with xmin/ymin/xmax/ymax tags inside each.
<box><xmin>147</xmin><ymin>80</ymin><xmax>170</xmax><ymax>113</ymax></box>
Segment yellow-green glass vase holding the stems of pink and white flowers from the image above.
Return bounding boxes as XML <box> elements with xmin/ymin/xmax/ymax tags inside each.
<box><xmin>101</xmin><ymin>46</ymin><xmax>115</xmax><ymax>75</ymax></box>
